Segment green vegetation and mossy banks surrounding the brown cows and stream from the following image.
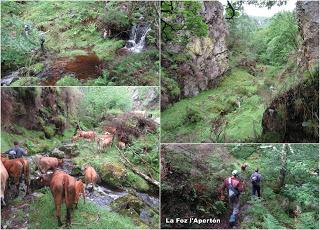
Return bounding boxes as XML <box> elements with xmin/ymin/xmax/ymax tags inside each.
<box><xmin>1</xmin><ymin>87</ymin><xmax>159</xmax><ymax>228</ymax></box>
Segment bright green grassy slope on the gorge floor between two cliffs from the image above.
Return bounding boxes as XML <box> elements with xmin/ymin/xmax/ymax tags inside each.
<box><xmin>161</xmin><ymin>66</ymin><xmax>304</xmax><ymax>142</ymax></box>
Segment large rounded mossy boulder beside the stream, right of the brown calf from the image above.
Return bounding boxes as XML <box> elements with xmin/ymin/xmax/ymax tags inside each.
<box><xmin>98</xmin><ymin>162</ymin><xmax>127</xmax><ymax>187</ymax></box>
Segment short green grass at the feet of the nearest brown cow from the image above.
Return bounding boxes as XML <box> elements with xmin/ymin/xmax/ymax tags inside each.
<box><xmin>28</xmin><ymin>190</ymin><xmax>137</xmax><ymax>229</ymax></box>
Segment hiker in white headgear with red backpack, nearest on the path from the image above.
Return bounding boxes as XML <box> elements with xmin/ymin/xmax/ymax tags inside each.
<box><xmin>222</xmin><ymin>170</ymin><xmax>244</xmax><ymax>227</ymax></box>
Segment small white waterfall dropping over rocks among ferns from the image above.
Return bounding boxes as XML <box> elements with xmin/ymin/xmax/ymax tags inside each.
<box><xmin>125</xmin><ymin>23</ymin><xmax>151</xmax><ymax>53</ymax></box>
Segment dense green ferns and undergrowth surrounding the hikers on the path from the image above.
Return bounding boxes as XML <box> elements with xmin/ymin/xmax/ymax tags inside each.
<box><xmin>161</xmin><ymin>144</ymin><xmax>319</xmax><ymax>229</ymax></box>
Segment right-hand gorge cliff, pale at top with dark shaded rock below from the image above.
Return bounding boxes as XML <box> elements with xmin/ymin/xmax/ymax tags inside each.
<box><xmin>261</xmin><ymin>1</ymin><xmax>319</xmax><ymax>143</ymax></box>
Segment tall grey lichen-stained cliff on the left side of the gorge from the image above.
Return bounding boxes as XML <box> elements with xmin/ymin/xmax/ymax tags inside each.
<box><xmin>161</xmin><ymin>1</ymin><xmax>229</xmax><ymax>109</ymax></box>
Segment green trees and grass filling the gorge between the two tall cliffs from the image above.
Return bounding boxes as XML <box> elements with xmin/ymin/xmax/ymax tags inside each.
<box><xmin>161</xmin><ymin>3</ymin><xmax>318</xmax><ymax>143</ymax></box>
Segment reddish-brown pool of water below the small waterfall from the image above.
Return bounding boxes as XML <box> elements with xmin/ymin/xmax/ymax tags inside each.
<box><xmin>40</xmin><ymin>52</ymin><xmax>103</xmax><ymax>86</ymax></box>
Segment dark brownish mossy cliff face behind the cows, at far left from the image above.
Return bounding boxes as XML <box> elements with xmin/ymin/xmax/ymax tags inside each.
<box><xmin>1</xmin><ymin>87</ymin><xmax>74</xmax><ymax>138</ymax></box>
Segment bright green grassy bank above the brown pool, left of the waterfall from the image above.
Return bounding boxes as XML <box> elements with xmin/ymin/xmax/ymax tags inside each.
<box><xmin>23</xmin><ymin>1</ymin><xmax>123</xmax><ymax>60</ymax></box>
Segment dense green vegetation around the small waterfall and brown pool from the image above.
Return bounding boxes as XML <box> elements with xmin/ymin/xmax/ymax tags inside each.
<box><xmin>1</xmin><ymin>1</ymin><xmax>159</xmax><ymax>86</ymax></box>
